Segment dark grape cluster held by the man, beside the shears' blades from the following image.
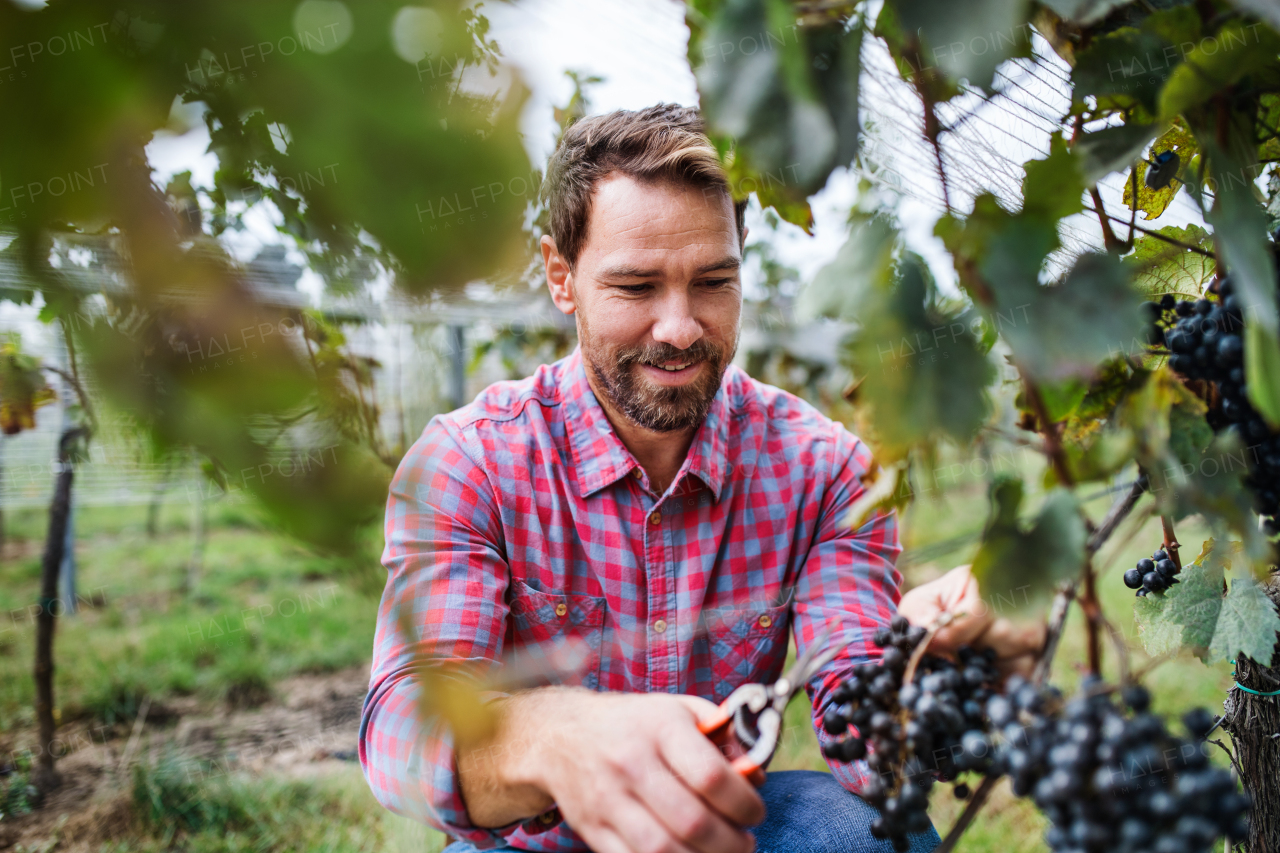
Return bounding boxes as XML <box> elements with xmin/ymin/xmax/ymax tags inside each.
<box><xmin>822</xmin><ymin>616</ymin><xmax>1000</xmax><ymax>850</ymax></box>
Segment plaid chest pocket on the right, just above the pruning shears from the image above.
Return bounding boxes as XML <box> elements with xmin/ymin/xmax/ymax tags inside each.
<box><xmin>694</xmin><ymin>596</ymin><xmax>791</xmax><ymax>702</ymax></box>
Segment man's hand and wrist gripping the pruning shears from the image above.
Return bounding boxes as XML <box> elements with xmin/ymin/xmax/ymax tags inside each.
<box><xmin>458</xmin><ymin>688</ymin><xmax>764</xmax><ymax>853</ymax></box>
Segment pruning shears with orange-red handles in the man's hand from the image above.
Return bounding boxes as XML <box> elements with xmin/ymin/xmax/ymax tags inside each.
<box><xmin>698</xmin><ymin>628</ymin><xmax>840</xmax><ymax>788</ymax></box>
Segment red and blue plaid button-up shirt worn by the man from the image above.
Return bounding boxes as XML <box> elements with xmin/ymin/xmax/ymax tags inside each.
<box><xmin>360</xmin><ymin>352</ymin><xmax>901</xmax><ymax>850</ymax></box>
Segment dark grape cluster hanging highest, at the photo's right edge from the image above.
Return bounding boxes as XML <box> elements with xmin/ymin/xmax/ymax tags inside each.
<box><xmin>1144</xmin><ymin>275</ymin><xmax>1280</xmax><ymax>517</ymax></box>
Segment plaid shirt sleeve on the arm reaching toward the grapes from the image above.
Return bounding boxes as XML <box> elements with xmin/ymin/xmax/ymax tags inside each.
<box><xmin>794</xmin><ymin>424</ymin><xmax>902</xmax><ymax>793</ymax></box>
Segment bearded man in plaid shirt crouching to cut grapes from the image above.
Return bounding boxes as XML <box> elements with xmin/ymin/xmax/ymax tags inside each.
<box><xmin>361</xmin><ymin>105</ymin><xmax>1039</xmax><ymax>853</ymax></box>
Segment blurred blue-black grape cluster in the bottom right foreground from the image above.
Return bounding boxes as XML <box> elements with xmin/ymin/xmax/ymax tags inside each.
<box><xmin>986</xmin><ymin>676</ymin><xmax>1249</xmax><ymax>853</ymax></box>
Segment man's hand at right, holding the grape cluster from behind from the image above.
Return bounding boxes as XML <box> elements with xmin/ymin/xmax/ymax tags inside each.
<box><xmin>897</xmin><ymin>566</ymin><xmax>1044</xmax><ymax>674</ymax></box>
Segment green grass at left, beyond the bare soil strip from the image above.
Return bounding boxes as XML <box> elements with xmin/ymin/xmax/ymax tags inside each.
<box><xmin>0</xmin><ymin>505</ymin><xmax>383</xmax><ymax>734</ymax></box>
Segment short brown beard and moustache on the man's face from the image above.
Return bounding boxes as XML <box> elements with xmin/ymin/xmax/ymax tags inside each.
<box><xmin>579</xmin><ymin>314</ymin><xmax>737</xmax><ymax>433</ymax></box>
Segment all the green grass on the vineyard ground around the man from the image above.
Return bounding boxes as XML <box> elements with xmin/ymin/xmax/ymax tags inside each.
<box><xmin>0</xmin><ymin>479</ymin><xmax>1249</xmax><ymax>853</ymax></box>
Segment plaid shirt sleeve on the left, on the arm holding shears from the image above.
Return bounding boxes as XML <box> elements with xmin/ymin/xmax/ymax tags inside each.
<box><xmin>360</xmin><ymin>419</ymin><xmax>518</xmax><ymax>848</ymax></box>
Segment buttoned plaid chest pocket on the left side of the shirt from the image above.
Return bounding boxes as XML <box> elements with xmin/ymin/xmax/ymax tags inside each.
<box><xmin>511</xmin><ymin>578</ymin><xmax>605</xmax><ymax>690</ymax></box>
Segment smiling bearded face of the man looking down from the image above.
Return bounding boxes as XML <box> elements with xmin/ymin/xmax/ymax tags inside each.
<box><xmin>543</xmin><ymin>174</ymin><xmax>742</xmax><ymax>432</ymax></box>
